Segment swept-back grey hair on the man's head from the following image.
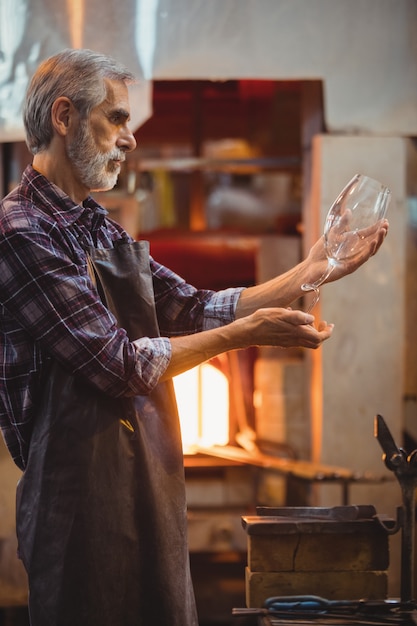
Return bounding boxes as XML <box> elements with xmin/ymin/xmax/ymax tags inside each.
<box><xmin>23</xmin><ymin>49</ymin><xmax>135</xmax><ymax>154</ymax></box>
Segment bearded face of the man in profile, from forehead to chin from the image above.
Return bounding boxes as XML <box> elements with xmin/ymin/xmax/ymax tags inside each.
<box><xmin>67</xmin><ymin>81</ymin><xmax>136</xmax><ymax>191</ymax></box>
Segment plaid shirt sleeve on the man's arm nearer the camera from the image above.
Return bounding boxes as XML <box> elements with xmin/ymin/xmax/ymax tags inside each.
<box><xmin>0</xmin><ymin>224</ymin><xmax>170</xmax><ymax>397</ymax></box>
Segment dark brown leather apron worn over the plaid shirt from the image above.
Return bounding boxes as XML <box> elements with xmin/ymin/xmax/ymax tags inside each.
<box><xmin>17</xmin><ymin>242</ymin><xmax>198</xmax><ymax>626</ymax></box>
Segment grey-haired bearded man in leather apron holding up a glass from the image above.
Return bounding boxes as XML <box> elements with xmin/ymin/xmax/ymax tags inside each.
<box><xmin>0</xmin><ymin>50</ymin><xmax>388</xmax><ymax>626</ymax></box>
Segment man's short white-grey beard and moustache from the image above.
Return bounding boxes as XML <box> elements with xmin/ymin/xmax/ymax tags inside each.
<box><xmin>68</xmin><ymin>121</ymin><xmax>125</xmax><ymax>191</ymax></box>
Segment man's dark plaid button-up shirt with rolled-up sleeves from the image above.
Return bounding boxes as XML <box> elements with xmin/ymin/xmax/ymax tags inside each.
<box><xmin>0</xmin><ymin>166</ymin><xmax>241</xmax><ymax>469</ymax></box>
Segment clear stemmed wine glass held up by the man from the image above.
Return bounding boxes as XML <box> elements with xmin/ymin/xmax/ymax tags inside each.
<box><xmin>301</xmin><ymin>174</ymin><xmax>391</xmax><ymax>312</ymax></box>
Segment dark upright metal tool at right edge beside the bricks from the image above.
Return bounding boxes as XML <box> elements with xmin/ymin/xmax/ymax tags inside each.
<box><xmin>374</xmin><ymin>415</ymin><xmax>417</xmax><ymax>602</ymax></box>
